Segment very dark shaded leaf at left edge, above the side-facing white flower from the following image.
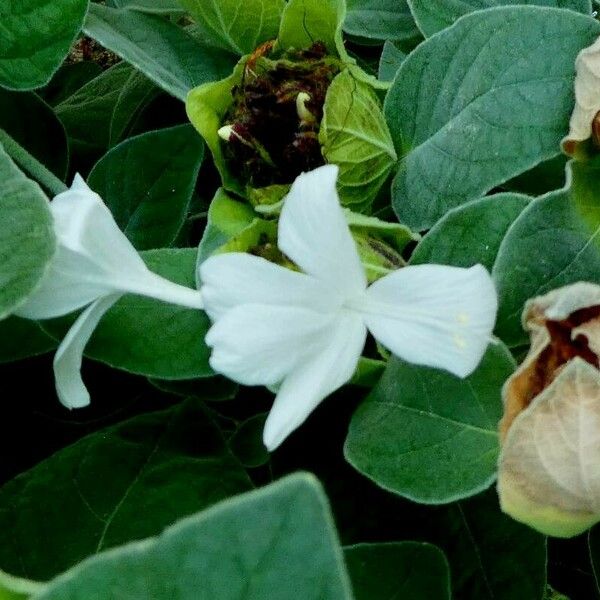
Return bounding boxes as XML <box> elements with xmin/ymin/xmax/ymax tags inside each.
<box><xmin>0</xmin><ymin>89</ymin><xmax>69</xmax><ymax>179</ymax></box>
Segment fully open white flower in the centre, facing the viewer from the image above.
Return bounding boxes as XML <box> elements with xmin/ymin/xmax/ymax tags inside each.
<box><xmin>200</xmin><ymin>166</ymin><xmax>497</xmax><ymax>450</ymax></box>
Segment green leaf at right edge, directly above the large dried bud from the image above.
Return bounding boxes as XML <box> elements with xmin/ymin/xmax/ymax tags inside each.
<box><xmin>492</xmin><ymin>163</ymin><xmax>600</xmax><ymax>347</ymax></box>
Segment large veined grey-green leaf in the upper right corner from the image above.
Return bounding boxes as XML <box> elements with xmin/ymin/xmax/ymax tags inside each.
<box><xmin>384</xmin><ymin>6</ymin><xmax>600</xmax><ymax>230</ymax></box>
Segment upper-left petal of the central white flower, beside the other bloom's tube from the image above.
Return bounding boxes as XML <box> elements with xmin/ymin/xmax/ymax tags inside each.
<box><xmin>199</xmin><ymin>252</ymin><xmax>341</xmax><ymax>321</ymax></box>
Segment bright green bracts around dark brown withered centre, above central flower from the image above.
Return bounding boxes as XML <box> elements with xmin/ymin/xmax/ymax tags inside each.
<box><xmin>186</xmin><ymin>0</ymin><xmax>396</xmax><ymax>212</ymax></box>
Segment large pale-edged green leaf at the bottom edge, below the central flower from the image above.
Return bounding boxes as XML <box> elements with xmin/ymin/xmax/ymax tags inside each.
<box><xmin>36</xmin><ymin>475</ymin><xmax>351</xmax><ymax>600</ymax></box>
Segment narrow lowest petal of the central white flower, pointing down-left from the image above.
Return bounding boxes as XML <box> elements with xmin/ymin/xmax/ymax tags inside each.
<box><xmin>263</xmin><ymin>313</ymin><xmax>367</xmax><ymax>451</ymax></box>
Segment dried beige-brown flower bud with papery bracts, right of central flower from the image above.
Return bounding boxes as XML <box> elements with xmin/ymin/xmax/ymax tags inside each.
<box><xmin>498</xmin><ymin>283</ymin><xmax>600</xmax><ymax>537</ymax></box>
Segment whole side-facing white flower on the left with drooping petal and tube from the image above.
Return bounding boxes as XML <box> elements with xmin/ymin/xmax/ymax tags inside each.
<box><xmin>17</xmin><ymin>175</ymin><xmax>203</xmax><ymax>408</ymax></box>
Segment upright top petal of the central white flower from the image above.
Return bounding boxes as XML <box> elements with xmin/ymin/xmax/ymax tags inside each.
<box><xmin>277</xmin><ymin>165</ymin><xmax>367</xmax><ymax>295</ymax></box>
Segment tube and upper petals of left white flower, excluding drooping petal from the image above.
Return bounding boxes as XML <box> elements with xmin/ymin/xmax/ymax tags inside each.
<box><xmin>17</xmin><ymin>176</ymin><xmax>202</xmax><ymax>319</ymax></box>
